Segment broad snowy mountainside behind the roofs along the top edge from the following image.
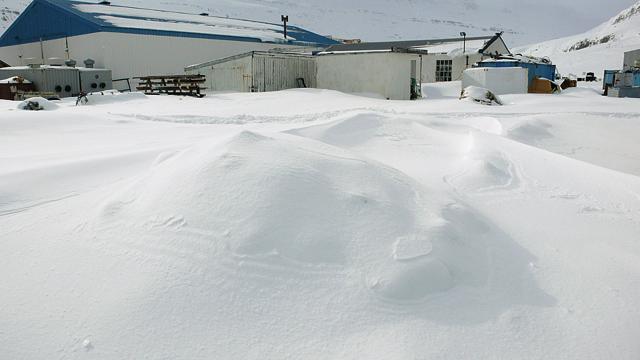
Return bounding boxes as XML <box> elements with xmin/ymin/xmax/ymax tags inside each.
<box><xmin>0</xmin><ymin>0</ymin><xmax>632</xmax><ymax>45</ymax></box>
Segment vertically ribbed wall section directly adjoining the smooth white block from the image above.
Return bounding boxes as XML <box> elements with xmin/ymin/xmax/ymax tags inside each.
<box><xmin>253</xmin><ymin>54</ymin><xmax>316</xmax><ymax>92</ymax></box>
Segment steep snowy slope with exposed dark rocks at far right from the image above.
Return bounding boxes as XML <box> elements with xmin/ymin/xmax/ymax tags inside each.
<box><xmin>516</xmin><ymin>1</ymin><xmax>640</xmax><ymax>76</ymax></box>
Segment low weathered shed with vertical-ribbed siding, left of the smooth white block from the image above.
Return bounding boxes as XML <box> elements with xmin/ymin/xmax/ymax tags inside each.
<box><xmin>185</xmin><ymin>51</ymin><xmax>316</xmax><ymax>92</ymax></box>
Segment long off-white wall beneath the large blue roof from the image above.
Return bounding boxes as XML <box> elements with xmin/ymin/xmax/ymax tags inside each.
<box><xmin>0</xmin><ymin>32</ymin><xmax>296</xmax><ymax>78</ymax></box>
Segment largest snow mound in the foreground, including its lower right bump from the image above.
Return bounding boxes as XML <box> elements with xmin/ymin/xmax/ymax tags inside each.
<box><xmin>94</xmin><ymin>129</ymin><xmax>540</xmax><ymax>304</ymax></box>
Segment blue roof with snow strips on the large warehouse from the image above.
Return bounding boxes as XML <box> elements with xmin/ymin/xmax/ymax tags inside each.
<box><xmin>0</xmin><ymin>0</ymin><xmax>338</xmax><ymax>47</ymax></box>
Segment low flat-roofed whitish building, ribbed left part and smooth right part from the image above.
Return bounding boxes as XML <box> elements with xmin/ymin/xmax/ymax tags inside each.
<box><xmin>185</xmin><ymin>49</ymin><xmax>422</xmax><ymax>100</ymax></box>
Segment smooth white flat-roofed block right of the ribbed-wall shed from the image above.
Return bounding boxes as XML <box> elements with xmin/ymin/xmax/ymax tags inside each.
<box><xmin>316</xmin><ymin>53</ymin><xmax>420</xmax><ymax>100</ymax></box>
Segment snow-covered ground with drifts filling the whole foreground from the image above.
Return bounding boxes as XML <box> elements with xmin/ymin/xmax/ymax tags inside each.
<box><xmin>0</xmin><ymin>83</ymin><xmax>640</xmax><ymax>360</ymax></box>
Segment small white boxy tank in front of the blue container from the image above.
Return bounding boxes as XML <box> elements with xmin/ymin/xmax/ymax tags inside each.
<box><xmin>462</xmin><ymin>67</ymin><xmax>529</xmax><ymax>95</ymax></box>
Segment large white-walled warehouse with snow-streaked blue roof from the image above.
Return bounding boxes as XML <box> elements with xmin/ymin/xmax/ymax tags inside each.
<box><xmin>0</xmin><ymin>0</ymin><xmax>337</xmax><ymax>78</ymax></box>
